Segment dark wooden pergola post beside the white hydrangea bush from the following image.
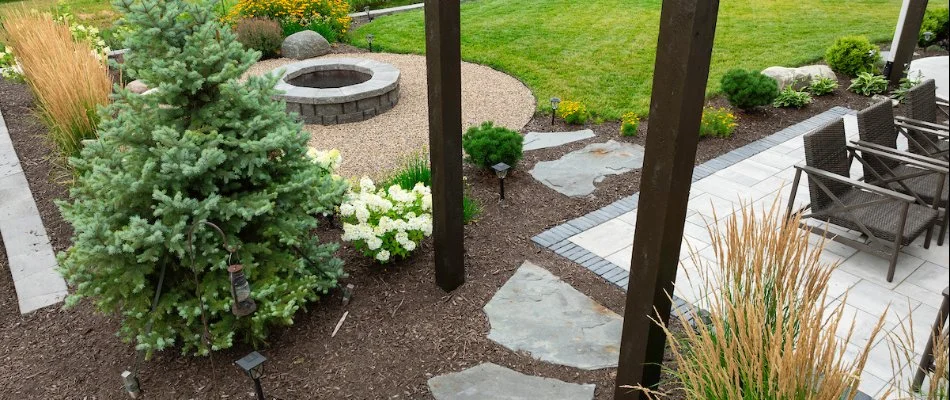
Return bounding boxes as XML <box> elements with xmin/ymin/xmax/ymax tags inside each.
<box><xmin>425</xmin><ymin>0</ymin><xmax>465</xmax><ymax>292</ymax></box>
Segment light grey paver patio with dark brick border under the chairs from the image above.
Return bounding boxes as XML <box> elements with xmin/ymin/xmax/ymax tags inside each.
<box><xmin>533</xmin><ymin>107</ymin><xmax>950</xmax><ymax>396</ymax></box>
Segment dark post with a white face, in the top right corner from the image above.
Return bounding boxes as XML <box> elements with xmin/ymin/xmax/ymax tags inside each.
<box><xmin>884</xmin><ymin>0</ymin><xmax>936</xmax><ymax>85</ymax></box>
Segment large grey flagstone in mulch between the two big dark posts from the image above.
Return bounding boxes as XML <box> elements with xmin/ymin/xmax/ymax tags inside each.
<box><xmin>484</xmin><ymin>261</ymin><xmax>623</xmax><ymax>370</ymax></box>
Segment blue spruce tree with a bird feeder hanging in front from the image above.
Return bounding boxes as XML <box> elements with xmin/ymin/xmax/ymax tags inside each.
<box><xmin>59</xmin><ymin>0</ymin><xmax>345</xmax><ymax>354</ymax></box>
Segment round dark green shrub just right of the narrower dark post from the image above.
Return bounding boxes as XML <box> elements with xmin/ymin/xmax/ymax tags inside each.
<box><xmin>462</xmin><ymin>122</ymin><xmax>524</xmax><ymax>168</ymax></box>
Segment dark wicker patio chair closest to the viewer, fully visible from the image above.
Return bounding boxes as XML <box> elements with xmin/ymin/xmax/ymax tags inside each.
<box><xmin>786</xmin><ymin>120</ymin><xmax>938</xmax><ymax>282</ymax></box>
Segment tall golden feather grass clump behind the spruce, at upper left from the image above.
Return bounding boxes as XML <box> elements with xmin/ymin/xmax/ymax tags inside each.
<box><xmin>0</xmin><ymin>9</ymin><xmax>112</xmax><ymax>157</ymax></box>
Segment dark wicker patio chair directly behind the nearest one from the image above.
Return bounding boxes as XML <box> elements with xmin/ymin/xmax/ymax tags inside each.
<box><xmin>849</xmin><ymin>106</ymin><xmax>950</xmax><ymax>246</ymax></box>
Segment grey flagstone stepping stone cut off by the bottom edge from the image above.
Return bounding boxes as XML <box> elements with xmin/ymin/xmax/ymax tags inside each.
<box><xmin>428</xmin><ymin>363</ymin><xmax>595</xmax><ymax>400</ymax></box>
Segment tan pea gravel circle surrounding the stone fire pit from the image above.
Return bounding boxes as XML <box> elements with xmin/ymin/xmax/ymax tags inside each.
<box><xmin>248</xmin><ymin>53</ymin><xmax>535</xmax><ymax>178</ymax></box>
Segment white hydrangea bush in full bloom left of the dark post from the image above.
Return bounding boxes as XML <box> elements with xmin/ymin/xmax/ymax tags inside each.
<box><xmin>340</xmin><ymin>177</ymin><xmax>432</xmax><ymax>263</ymax></box>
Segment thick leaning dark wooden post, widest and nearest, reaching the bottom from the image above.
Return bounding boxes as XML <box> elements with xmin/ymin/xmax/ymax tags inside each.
<box><xmin>614</xmin><ymin>0</ymin><xmax>719</xmax><ymax>400</ymax></box>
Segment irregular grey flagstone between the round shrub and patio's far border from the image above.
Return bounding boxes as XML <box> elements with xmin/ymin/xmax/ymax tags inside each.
<box><xmin>530</xmin><ymin>140</ymin><xmax>643</xmax><ymax>197</ymax></box>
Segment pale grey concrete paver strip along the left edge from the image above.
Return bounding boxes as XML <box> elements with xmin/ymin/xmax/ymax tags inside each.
<box><xmin>0</xmin><ymin>103</ymin><xmax>67</xmax><ymax>314</ymax></box>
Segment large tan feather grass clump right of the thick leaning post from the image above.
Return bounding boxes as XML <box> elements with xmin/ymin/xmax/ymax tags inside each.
<box><xmin>636</xmin><ymin>201</ymin><xmax>884</xmax><ymax>400</ymax></box>
